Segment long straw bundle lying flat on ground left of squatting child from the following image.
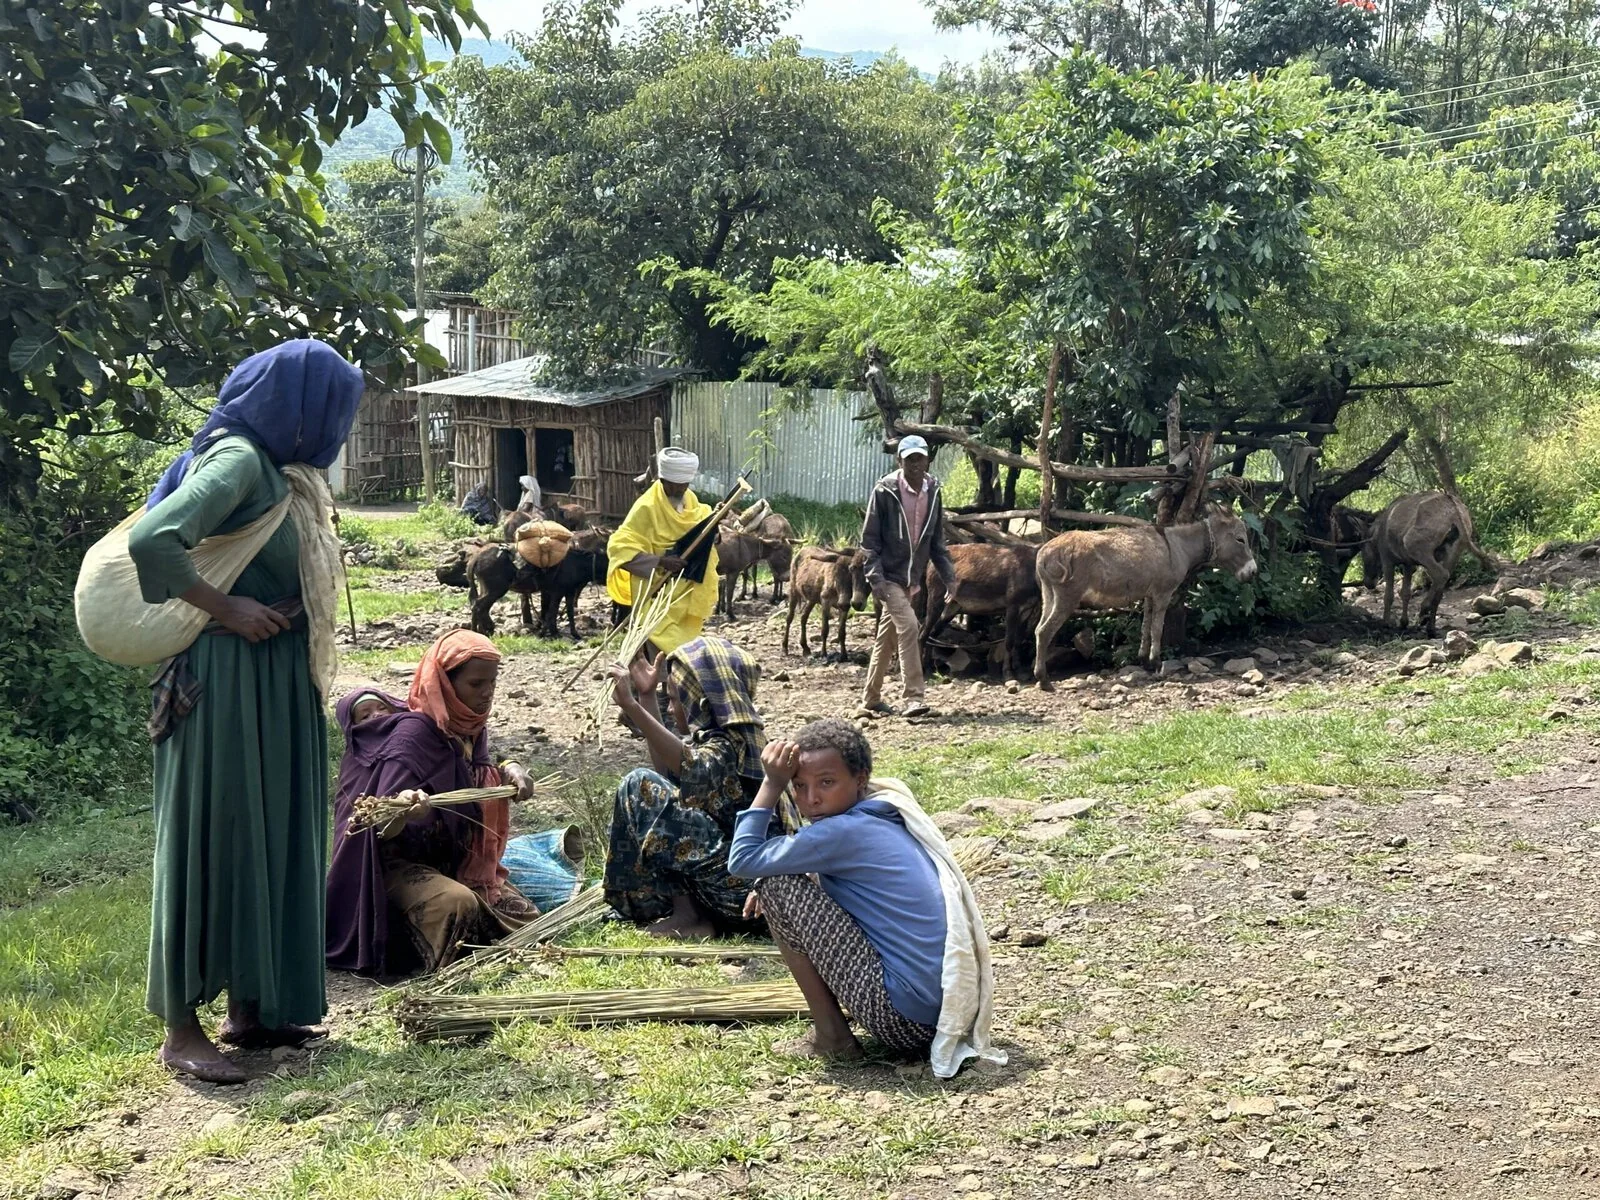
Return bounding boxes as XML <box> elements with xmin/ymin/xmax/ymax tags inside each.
<box><xmin>395</xmin><ymin>979</ymin><xmax>806</xmax><ymax>1042</ymax></box>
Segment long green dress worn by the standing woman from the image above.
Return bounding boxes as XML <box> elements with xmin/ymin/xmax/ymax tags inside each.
<box><xmin>130</xmin><ymin>437</ymin><xmax>328</xmax><ymax>1027</ymax></box>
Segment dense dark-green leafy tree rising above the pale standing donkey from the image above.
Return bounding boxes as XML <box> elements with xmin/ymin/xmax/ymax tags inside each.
<box><xmin>939</xmin><ymin>54</ymin><xmax>1317</xmax><ymax>464</ymax></box>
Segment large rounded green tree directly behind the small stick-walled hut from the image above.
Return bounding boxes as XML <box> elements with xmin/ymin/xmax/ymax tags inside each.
<box><xmin>453</xmin><ymin>0</ymin><xmax>944</xmax><ymax>376</ymax></box>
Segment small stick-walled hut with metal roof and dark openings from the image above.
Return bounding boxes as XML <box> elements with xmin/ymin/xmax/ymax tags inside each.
<box><xmin>410</xmin><ymin>357</ymin><xmax>686</xmax><ymax>518</ymax></box>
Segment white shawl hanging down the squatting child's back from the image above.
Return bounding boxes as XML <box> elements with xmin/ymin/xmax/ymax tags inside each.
<box><xmin>867</xmin><ymin>779</ymin><xmax>1006</xmax><ymax>1078</ymax></box>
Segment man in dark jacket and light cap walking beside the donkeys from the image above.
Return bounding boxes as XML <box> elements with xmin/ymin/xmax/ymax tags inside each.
<box><xmin>861</xmin><ymin>434</ymin><xmax>955</xmax><ymax>717</ymax></box>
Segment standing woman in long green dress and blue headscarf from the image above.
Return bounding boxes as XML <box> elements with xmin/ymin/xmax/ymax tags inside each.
<box><xmin>128</xmin><ymin>341</ymin><xmax>362</xmax><ymax>1083</ymax></box>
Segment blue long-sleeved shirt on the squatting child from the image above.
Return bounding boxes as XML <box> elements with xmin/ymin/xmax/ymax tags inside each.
<box><xmin>728</xmin><ymin>798</ymin><xmax>944</xmax><ymax>1026</ymax></box>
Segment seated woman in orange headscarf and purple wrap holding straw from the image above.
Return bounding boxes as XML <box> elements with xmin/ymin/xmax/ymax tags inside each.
<box><xmin>326</xmin><ymin>629</ymin><xmax>536</xmax><ymax>974</ymax></box>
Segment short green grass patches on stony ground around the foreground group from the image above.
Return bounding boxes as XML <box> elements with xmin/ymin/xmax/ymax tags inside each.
<box><xmin>0</xmin><ymin>646</ymin><xmax>1600</xmax><ymax>1200</ymax></box>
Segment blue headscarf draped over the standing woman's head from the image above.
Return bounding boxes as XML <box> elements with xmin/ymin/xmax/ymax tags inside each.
<box><xmin>146</xmin><ymin>338</ymin><xmax>365</xmax><ymax>509</ymax></box>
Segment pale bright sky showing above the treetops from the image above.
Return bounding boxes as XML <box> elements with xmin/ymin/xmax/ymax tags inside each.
<box><xmin>475</xmin><ymin>0</ymin><xmax>998</xmax><ymax>72</ymax></box>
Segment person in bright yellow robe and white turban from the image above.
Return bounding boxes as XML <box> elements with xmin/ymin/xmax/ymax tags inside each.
<box><xmin>605</xmin><ymin>446</ymin><xmax>717</xmax><ymax>653</ymax></box>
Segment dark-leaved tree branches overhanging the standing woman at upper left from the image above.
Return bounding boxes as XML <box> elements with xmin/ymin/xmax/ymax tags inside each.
<box><xmin>0</xmin><ymin>0</ymin><xmax>477</xmax><ymax>491</ymax></box>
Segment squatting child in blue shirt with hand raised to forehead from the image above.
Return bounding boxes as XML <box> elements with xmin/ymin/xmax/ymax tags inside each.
<box><xmin>728</xmin><ymin>718</ymin><xmax>946</xmax><ymax>1059</ymax></box>
